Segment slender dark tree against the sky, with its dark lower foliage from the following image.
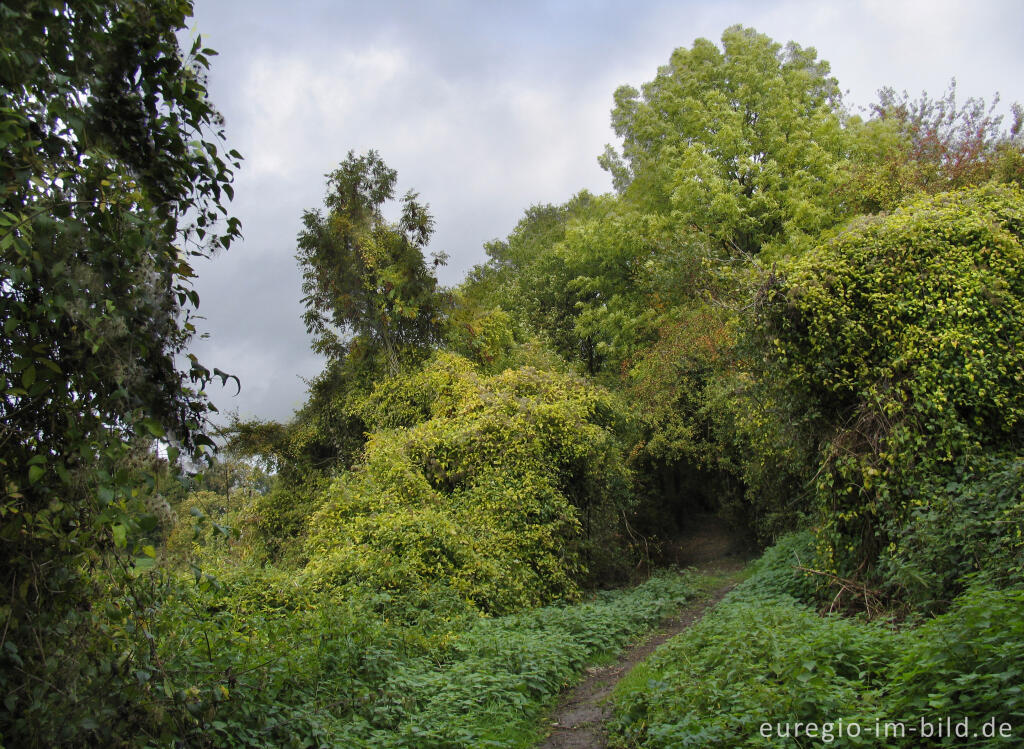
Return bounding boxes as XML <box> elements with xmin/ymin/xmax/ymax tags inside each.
<box><xmin>228</xmin><ymin>151</ymin><xmax>450</xmax><ymax>516</ymax></box>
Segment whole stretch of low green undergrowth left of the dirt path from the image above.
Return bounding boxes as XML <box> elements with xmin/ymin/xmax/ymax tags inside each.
<box><xmin>19</xmin><ymin>568</ymin><xmax>697</xmax><ymax>748</ymax></box>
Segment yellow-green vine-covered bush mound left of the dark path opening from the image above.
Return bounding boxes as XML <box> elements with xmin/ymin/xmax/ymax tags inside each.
<box><xmin>306</xmin><ymin>353</ymin><xmax>629</xmax><ymax>613</ymax></box>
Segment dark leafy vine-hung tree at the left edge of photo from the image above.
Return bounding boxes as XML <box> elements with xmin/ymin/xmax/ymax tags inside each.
<box><xmin>0</xmin><ymin>0</ymin><xmax>240</xmax><ymax>742</ymax></box>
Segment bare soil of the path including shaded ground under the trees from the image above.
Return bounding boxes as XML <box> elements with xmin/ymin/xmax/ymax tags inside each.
<box><xmin>539</xmin><ymin>516</ymin><xmax>748</xmax><ymax>749</ymax></box>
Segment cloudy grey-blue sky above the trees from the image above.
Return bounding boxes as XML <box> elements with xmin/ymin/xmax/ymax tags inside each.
<box><xmin>182</xmin><ymin>0</ymin><xmax>1024</xmax><ymax>421</ymax></box>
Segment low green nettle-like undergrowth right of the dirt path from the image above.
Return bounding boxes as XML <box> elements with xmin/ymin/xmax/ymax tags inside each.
<box><xmin>610</xmin><ymin>534</ymin><xmax>1024</xmax><ymax>748</ymax></box>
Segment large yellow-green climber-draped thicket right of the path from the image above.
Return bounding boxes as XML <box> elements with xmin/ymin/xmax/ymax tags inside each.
<box><xmin>759</xmin><ymin>188</ymin><xmax>1024</xmax><ymax>597</ymax></box>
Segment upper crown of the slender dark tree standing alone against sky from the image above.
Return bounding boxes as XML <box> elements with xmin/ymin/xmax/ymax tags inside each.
<box><xmin>296</xmin><ymin>151</ymin><xmax>445</xmax><ymax>374</ymax></box>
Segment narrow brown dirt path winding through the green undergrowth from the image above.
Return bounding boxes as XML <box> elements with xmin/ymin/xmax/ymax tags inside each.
<box><xmin>539</xmin><ymin>557</ymin><xmax>745</xmax><ymax>749</ymax></box>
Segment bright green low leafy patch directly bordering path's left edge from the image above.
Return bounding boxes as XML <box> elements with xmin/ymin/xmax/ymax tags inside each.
<box><xmin>356</xmin><ymin>575</ymin><xmax>694</xmax><ymax>747</ymax></box>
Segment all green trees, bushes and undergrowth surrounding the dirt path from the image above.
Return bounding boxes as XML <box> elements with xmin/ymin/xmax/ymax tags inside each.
<box><xmin>0</xmin><ymin>8</ymin><xmax>1024</xmax><ymax>747</ymax></box>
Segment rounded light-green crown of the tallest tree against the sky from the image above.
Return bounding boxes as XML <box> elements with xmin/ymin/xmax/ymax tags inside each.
<box><xmin>600</xmin><ymin>26</ymin><xmax>845</xmax><ymax>253</ymax></box>
